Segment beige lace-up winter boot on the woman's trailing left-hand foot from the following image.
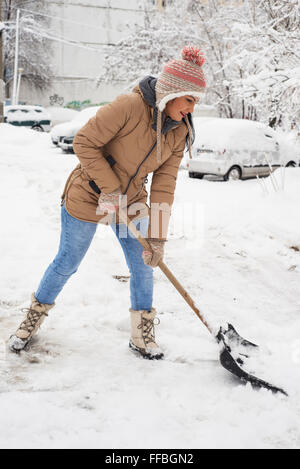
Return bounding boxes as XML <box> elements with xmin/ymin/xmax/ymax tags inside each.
<box><xmin>8</xmin><ymin>293</ymin><xmax>55</xmax><ymax>352</ymax></box>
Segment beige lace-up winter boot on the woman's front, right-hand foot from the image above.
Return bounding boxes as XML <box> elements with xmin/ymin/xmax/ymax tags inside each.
<box><xmin>129</xmin><ymin>308</ymin><xmax>164</xmax><ymax>360</ymax></box>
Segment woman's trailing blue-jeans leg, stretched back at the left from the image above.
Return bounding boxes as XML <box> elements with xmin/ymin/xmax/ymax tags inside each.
<box><xmin>35</xmin><ymin>206</ymin><xmax>97</xmax><ymax>304</ymax></box>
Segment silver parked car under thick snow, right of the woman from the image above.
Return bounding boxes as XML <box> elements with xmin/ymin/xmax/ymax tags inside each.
<box><xmin>187</xmin><ymin>118</ymin><xmax>300</xmax><ymax>180</ymax></box>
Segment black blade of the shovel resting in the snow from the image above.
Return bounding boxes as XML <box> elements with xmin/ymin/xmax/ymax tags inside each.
<box><xmin>217</xmin><ymin>329</ymin><xmax>288</xmax><ymax>396</ymax></box>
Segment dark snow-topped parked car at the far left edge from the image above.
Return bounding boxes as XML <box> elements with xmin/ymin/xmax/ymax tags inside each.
<box><xmin>4</xmin><ymin>105</ymin><xmax>51</xmax><ymax>132</ymax></box>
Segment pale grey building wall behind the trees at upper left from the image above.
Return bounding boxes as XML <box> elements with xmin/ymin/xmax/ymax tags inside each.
<box><xmin>20</xmin><ymin>0</ymin><xmax>166</xmax><ymax>106</ymax></box>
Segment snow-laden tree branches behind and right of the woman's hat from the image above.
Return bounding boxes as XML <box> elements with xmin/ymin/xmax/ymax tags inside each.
<box><xmin>98</xmin><ymin>0</ymin><xmax>300</xmax><ymax>132</ymax></box>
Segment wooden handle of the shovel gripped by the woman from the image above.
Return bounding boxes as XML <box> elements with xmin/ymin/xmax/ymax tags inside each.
<box><xmin>119</xmin><ymin>209</ymin><xmax>213</xmax><ymax>334</ymax></box>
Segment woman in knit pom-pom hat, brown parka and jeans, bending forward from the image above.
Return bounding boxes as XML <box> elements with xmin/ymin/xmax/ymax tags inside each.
<box><xmin>9</xmin><ymin>46</ymin><xmax>206</xmax><ymax>359</ymax></box>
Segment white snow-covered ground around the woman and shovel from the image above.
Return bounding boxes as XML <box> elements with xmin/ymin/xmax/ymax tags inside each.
<box><xmin>0</xmin><ymin>125</ymin><xmax>300</xmax><ymax>449</ymax></box>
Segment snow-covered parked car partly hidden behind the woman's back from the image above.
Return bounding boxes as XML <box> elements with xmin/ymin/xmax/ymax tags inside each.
<box><xmin>50</xmin><ymin>106</ymin><xmax>99</xmax><ymax>153</ymax></box>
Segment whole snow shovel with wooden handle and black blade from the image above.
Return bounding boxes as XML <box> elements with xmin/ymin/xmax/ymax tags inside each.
<box><xmin>119</xmin><ymin>210</ymin><xmax>288</xmax><ymax>396</ymax></box>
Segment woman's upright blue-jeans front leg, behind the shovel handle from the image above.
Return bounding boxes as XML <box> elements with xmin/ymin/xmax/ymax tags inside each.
<box><xmin>111</xmin><ymin>218</ymin><xmax>153</xmax><ymax>311</ymax></box>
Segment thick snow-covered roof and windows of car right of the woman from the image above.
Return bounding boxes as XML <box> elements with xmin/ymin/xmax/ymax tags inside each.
<box><xmin>194</xmin><ymin>117</ymin><xmax>277</xmax><ymax>151</ymax></box>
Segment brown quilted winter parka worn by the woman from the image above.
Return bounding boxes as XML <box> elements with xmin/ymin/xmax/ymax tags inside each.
<box><xmin>62</xmin><ymin>86</ymin><xmax>188</xmax><ymax>239</ymax></box>
